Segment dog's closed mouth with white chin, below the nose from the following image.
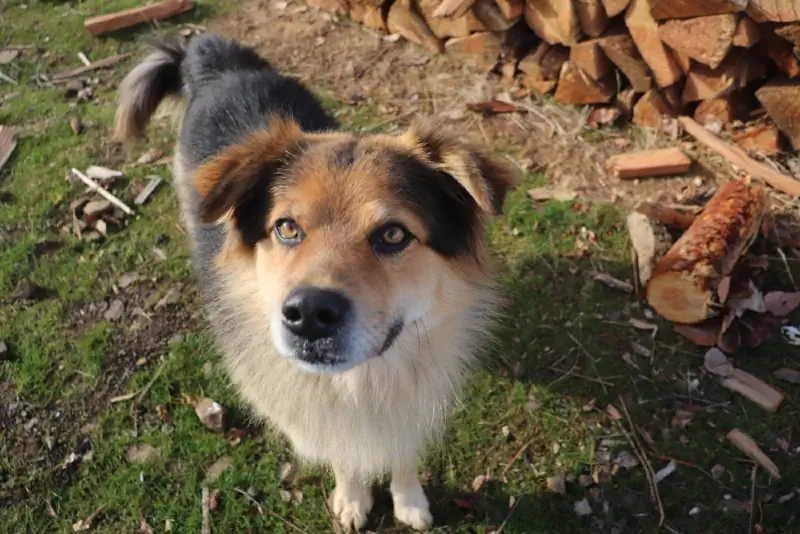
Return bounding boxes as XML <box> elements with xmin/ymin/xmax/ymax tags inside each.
<box><xmin>292</xmin><ymin>320</ymin><xmax>403</xmax><ymax>373</ymax></box>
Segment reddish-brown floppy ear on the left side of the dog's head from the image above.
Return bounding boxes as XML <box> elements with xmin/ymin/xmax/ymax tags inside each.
<box><xmin>194</xmin><ymin>118</ymin><xmax>308</xmax><ymax>223</ymax></box>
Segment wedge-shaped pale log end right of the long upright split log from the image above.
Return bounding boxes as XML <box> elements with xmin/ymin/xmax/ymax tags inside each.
<box><xmin>658</xmin><ymin>13</ymin><xmax>737</xmax><ymax>69</ymax></box>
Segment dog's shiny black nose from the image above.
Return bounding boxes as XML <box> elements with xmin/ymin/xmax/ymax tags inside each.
<box><xmin>282</xmin><ymin>287</ymin><xmax>350</xmax><ymax>341</ymax></box>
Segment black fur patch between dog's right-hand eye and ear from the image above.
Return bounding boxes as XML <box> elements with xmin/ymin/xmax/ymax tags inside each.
<box><xmin>390</xmin><ymin>152</ymin><xmax>480</xmax><ymax>257</ymax></box>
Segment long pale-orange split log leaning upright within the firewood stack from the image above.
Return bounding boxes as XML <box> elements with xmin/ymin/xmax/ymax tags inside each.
<box><xmin>625</xmin><ymin>0</ymin><xmax>683</xmax><ymax>87</ymax></box>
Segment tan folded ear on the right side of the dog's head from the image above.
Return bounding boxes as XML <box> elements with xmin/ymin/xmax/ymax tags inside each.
<box><xmin>399</xmin><ymin>122</ymin><xmax>520</xmax><ymax>215</ymax></box>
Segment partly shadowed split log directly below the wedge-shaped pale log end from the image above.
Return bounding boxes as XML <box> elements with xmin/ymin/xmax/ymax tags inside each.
<box><xmin>683</xmin><ymin>48</ymin><xmax>765</xmax><ymax>103</ymax></box>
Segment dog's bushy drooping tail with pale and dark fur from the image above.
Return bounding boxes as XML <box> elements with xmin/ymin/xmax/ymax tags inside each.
<box><xmin>114</xmin><ymin>40</ymin><xmax>186</xmax><ymax>142</ymax></box>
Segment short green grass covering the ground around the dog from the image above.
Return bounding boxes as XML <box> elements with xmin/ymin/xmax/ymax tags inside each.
<box><xmin>0</xmin><ymin>0</ymin><xmax>800</xmax><ymax>534</ymax></box>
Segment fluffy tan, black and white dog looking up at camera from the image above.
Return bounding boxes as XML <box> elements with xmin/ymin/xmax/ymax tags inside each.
<box><xmin>115</xmin><ymin>34</ymin><xmax>518</xmax><ymax>530</ymax></box>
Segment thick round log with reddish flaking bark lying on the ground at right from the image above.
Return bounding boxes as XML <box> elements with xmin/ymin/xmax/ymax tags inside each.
<box><xmin>646</xmin><ymin>180</ymin><xmax>768</xmax><ymax>324</ymax></box>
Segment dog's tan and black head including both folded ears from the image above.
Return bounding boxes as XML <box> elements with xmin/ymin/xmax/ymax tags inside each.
<box><xmin>195</xmin><ymin>120</ymin><xmax>515</xmax><ymax>372</ymax></box>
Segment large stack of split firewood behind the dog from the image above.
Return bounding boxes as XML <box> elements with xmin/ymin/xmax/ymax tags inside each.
<box><xmin>308</xmin><ymin>0</ymin><xmax>800</xmax><ymax>154</ymax></box>
